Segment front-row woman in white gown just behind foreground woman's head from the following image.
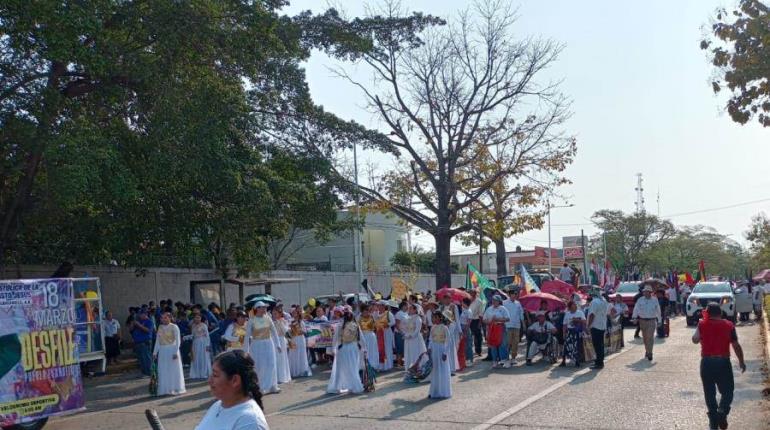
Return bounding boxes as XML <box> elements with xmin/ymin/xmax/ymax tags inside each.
<box><xmin>246</xmin><ymin>301</ymin><xmax>281</xmax><ymax>394</ymax></box>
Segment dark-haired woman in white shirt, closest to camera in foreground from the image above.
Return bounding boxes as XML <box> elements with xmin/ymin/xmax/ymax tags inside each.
<box><xmin>195</xmin><ymin>349</ymin><xmax>270</xmax><ymax>430</ymax></box>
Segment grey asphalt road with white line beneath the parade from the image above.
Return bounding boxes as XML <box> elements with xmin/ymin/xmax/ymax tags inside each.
<box><xmin>46</xmin><ymin>317</ymin><xmax>770</xmax><ymax>430</ymax></box>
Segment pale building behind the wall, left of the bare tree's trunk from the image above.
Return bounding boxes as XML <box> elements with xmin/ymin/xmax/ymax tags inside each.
<box><xmin>271</xmin><ymin>211</ymin><xmax>407</xmax><ymax>272</ymax></box>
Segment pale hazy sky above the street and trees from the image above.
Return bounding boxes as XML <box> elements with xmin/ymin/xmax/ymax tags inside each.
<box><xmin>286</xmin><ymin>0</ymin><xmax>770</xmax><ymax>254</ymax></box>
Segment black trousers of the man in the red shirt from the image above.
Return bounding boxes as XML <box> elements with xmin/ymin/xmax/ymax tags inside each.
<box><xmin>700</xmin><ymin>357</ymin><xmax>735</xmax><ymax>422</ymax></box>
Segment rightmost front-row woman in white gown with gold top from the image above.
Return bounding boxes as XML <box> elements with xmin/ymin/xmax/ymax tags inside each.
<box><xmin>428</xmin><ymin>311</ymin><xmax>454</xmax><ymax>399</ymax></box>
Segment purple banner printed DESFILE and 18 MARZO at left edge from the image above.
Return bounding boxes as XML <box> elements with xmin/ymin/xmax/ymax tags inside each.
<box><xmin>0</xmin><ymin>279</ymin><xmax>84</xmax><ymax>426</ymax></box>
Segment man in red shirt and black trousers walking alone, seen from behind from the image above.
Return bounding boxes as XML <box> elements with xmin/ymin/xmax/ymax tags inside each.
<box><xmin>692</xmin><ymin>303</ymin><xmax>746</xmax><ymax>429</ymax></box>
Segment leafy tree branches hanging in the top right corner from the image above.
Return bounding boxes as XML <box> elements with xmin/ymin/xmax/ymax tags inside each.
<box><xmin>700</xmin><ymin>0</ymin><xmax>770</xmax><ymax>127</ymax></box>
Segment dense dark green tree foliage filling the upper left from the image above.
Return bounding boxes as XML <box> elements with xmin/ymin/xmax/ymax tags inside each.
<box><xmin>0</xmin><ymin>0</ymin><xmax>424</xmax><ymax>272</ymax></box>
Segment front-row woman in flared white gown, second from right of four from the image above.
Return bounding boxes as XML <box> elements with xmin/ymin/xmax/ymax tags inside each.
<box><xmin>326</xmin><ymin>309</ymin><xmax>366</xmax><ymax>394</ymax></box>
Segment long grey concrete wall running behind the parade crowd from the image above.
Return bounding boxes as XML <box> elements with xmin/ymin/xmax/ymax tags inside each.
<box><xmin>0</xmin><ymin>265</ymin><xmax>465</xmax><ymax>335</ymax></box>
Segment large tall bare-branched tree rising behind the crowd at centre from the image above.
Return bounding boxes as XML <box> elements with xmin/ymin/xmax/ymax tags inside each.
<box><xmin>332</xmin><ymin>1</ymin><xmax>574</xmax><ymax>287</ymax></box>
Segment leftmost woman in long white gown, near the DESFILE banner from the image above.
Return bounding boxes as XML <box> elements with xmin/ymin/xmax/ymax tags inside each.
<box><xmin>153</xmin><ymin>312</ymin><xmax>186</xmax><ymax>396</ymax></box>
